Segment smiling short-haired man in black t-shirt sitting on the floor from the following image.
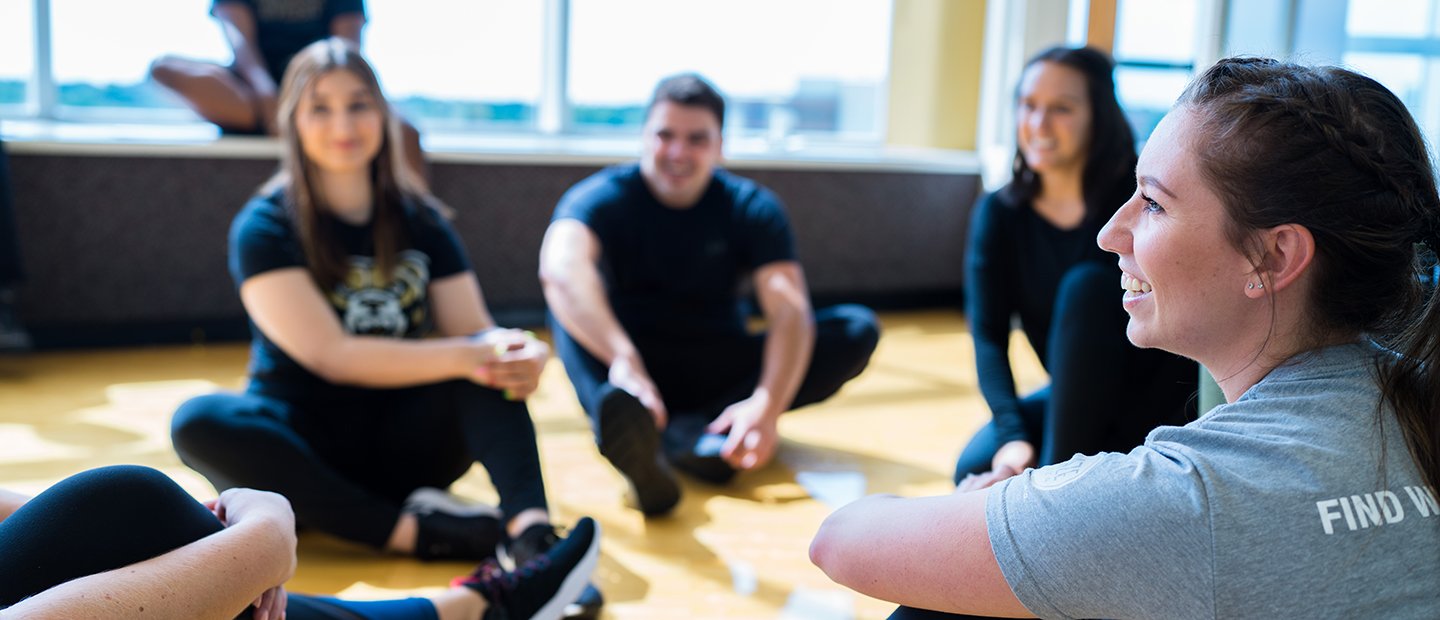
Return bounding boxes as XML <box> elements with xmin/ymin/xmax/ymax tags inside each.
<box><xmin>540</xmin><ymin>75</ymin><xmax>878</xmax><ymax>515</ymax></box>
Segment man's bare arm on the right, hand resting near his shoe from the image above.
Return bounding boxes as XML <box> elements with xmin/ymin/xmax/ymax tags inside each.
<box><xmin>708</xmin><ymin>260</ymin><xmax>815</xmax><ymax>469</ymax></box>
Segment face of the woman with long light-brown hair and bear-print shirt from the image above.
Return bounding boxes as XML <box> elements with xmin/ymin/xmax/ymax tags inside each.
<box><xmin>295</xmin><ymin>69</ymin><xmax>384</xmax><ymax>174</ymax></box>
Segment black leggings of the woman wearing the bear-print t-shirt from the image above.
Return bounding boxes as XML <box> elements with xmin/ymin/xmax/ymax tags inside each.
<box><xmin>171</xmin><ymin>381</ymin><xmax>546</xmax><ymax>548</ymax></box>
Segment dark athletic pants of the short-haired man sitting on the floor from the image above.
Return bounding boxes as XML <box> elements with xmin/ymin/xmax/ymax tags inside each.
<box><xmin>550</xmin><ymin>304</ymin><xmax>880</xmax><ymax>460</ymax></box>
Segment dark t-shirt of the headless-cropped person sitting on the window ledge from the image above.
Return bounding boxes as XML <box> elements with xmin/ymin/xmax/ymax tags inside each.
<box><xmin>210</xmin><ymin>0</ymin><xmax>364</xmax><ymax>85</ymax></box>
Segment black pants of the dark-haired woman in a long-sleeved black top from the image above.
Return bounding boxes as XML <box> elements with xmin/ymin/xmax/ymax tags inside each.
<box><xmin>955</xmin><ymin>263</ymin><xmax>1200</xmax><ymax>483</ymax></box>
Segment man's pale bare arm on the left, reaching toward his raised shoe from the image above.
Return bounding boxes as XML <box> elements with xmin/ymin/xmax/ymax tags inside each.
<box><xmin>540</xmin><ymin>219</ymin><xmax>668</xmax><ymax>426</ymax></box>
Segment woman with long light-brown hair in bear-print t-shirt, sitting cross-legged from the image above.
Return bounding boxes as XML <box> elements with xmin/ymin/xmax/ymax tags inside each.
<box><xmin>171</xmin><ymin>37</ymin><xmax>587</xmax><ymax>578</ymax></box>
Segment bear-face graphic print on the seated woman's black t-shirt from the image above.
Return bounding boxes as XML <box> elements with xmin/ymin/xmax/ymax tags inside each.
<box><xmin>330</xmin><ymin>250</ymin><xmax>431</xmax><ymax>338</ymax></box>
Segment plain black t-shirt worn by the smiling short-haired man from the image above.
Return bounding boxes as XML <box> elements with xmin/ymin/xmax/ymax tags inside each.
<box><xmin>552</xmin><ymin>164</ymin><xmax>795</xmax><ymax>338</ymax></box>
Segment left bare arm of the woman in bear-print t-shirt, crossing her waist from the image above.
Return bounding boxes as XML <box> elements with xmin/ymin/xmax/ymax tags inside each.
<box><xmin>240</xmin><ymin>268</ymin><xmax>495</xmax><ymax>387</ymax></box>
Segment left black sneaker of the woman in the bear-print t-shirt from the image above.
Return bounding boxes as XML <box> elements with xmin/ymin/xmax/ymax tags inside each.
<box><xmin>402</xmin><ymin>486</ymin><xmax>505</xmax><ymax>560</ymax></box>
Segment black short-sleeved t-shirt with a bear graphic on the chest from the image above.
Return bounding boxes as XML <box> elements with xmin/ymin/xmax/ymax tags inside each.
<box><xmin>229</xmin><ymin>191</ymin><xmax>469</xmax><ymax>398</ymax></box>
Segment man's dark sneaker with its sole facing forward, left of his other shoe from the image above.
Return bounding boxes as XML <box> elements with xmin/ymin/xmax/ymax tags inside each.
<box><xmin>596</xmin><ymin>386</ymin><xmax>680</xmax><ymax>516</ymax></box>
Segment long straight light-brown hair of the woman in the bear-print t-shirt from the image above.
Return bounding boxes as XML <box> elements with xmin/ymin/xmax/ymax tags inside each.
<box><xmin>261</xmin><ymin>37</ymin><xmax>437</xmax><ymax>291</ymax></box>
